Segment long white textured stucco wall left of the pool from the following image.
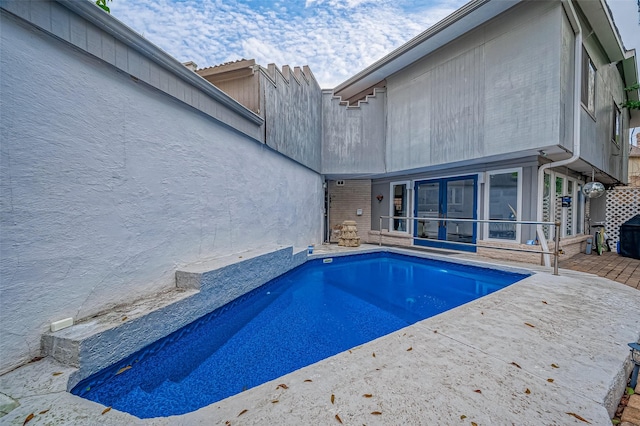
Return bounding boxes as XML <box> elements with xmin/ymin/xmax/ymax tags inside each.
<box><xmin>0</xmin><ymin>14</ymin><xmax>323</xmax><ymax>373</ymax></box>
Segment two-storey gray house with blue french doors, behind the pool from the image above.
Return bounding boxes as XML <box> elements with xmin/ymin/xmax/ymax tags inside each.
<box><xmin>322</xmin><ymin>0</ymin><xmax>638</xmax><ymax>261</ymax></box>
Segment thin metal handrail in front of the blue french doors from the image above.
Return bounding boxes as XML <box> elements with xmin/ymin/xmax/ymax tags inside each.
<box><xmin>379</xmin><ymin>216</ymin><xmax>560</xmax><ymax>275</ymax></box>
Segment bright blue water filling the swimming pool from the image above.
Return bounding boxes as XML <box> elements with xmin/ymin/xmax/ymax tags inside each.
<box><xmin>72</xmin><ymin>253</ymin><xmax>527</xmax><ymax>418</ymax></box>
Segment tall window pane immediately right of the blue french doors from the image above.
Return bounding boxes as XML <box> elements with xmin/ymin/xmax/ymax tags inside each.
<box><xmin>489</xmin><ymin>172</ymin><xmax>518</xmax><ymax>240</ymax></box>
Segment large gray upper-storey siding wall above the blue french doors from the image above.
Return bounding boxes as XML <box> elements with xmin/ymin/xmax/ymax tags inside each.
<box><xmin>387</xmin><ymin>2</ymin><xmax>562</xmax><ymax>172</ymax></box>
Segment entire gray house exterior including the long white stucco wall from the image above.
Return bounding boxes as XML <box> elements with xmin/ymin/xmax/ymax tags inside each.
<box><xmin>0</xmin><ymin>0</ymin><xmax>638</xmax><ymax>374</ymax></box>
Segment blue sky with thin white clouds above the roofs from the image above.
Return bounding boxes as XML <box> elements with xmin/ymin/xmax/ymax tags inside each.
<box><xmin>109</xmin><ymin>0</ymin><xmax>640</xmax><ymax>88</ymax></box>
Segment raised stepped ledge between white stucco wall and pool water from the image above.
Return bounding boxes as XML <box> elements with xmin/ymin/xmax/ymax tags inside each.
<box><xmin>41</xmin><ymin>246</ymin><xmax>307</xmax><ymax>389</ymax></box>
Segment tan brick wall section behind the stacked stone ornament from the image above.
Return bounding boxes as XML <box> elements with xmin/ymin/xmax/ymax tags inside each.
<box><xmin>329</xmin><ymin>179</ymin><xmax>371</xmax><ymax>243</ymax></box>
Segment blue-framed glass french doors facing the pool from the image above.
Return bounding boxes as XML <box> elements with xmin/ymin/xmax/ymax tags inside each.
<box><xmin>413</xmin><ymin>175</ymin><xmax>478</xmax><ymax>252</ymax></box>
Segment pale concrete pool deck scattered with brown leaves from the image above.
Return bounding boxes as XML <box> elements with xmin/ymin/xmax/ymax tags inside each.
<box><xmin>0</xmin><ymin>246</ymin><xmax>640</xmax><ymax>425</ymax></box>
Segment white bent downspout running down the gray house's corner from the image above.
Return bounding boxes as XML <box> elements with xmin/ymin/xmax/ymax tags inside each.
<box><xmin>536</xmin><ymin>0</ymin><xmax>582</xmax><ymax>266</ymax></box>
